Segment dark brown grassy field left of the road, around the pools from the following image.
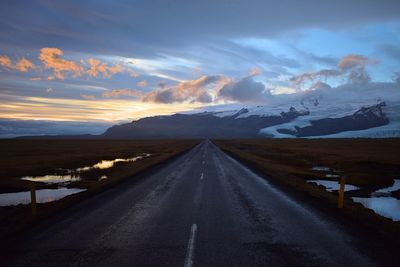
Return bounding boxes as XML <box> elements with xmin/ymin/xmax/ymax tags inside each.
<box><xmin>0</xmin><ymin>140</ymin><xmax>199</xmax><ymax>243</ymax></box>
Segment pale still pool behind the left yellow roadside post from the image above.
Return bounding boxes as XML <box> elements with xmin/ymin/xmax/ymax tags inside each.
<box><xmin>0</xmin><ymin>187</ymin><xmax>86</xmax><ymax>207</ymax></box>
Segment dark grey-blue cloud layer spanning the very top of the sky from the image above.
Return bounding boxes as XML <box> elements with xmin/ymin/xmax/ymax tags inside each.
<box><xmin>0</xmin><ymin>0</ymin><xmax>400</xmax><ymax>57</ymax></box>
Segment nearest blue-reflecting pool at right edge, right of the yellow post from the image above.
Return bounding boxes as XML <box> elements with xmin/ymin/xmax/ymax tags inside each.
<box><xmin>352</xmin><ymin>197</ymin><xmax>400</xmax><ymax>221</ymax></box>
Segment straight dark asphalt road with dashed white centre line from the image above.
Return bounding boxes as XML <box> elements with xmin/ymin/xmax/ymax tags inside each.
<box><xmin>4</xmin><ymin>141</ymin><xmax>373</xmax><ymax>267</ymax></box>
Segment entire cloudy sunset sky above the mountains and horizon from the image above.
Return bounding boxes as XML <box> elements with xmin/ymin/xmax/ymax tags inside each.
<box><xmin>0</xmin><ymin>0</ymin><xmax>400</xmax><ymax>130</ymax></box>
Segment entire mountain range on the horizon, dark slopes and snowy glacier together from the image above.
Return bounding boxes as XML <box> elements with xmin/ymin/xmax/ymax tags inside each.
<box><xmin>103</xmin><ymin>84</ymin><xmax>400</xmax><ymax>138</ymax></box>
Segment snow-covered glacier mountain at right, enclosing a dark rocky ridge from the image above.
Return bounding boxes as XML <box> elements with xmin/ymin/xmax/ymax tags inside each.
<box><xmin>261</xmin><ymin>84</ymin><xmax>400</xmax><ymax>138</ymax></box>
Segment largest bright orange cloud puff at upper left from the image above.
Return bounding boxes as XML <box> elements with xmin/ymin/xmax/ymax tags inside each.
<box><xmin>39</xmin><ymin>47</ymin><xmax>83</xmax><ymax>80</ymax></box>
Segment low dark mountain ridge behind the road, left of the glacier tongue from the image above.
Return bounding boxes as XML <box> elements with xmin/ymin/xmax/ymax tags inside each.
<box><xmin>102</xmin><ymin>108</ymin><xmax>309</xmax><ymax>139</ymax></box>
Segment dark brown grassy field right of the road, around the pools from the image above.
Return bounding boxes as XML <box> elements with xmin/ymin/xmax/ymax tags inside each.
<box><xmin>214</xmin><ymin>139</ymin><xmax>400</xmax><ymax>245</ymax></box>
